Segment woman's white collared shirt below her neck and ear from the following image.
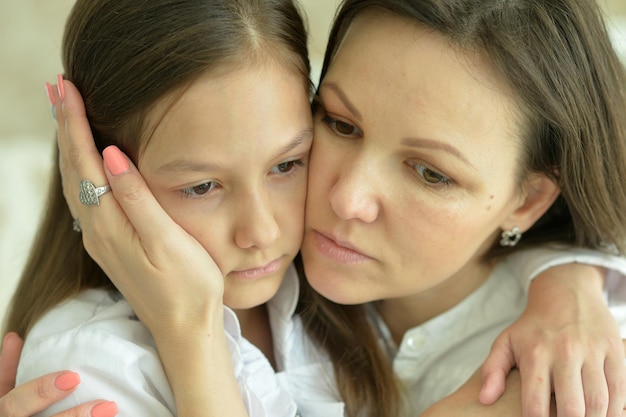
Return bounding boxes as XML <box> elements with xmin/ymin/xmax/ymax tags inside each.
<box><xmin>369</xmin><ymin>248</ymin><xmax>626</xmax><ymax>416</ymax></box>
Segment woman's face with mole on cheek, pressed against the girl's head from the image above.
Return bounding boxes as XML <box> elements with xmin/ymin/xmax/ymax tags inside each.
<box><xmin>302</xmin><ymin>11</ymin><xmax>523</xmax><ymax>304</ymax></box>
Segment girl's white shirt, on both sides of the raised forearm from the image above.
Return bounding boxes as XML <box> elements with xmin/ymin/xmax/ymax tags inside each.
<box><xmin>17</xmin><ymin>266</ymin><xmax>343</xmax><ymax>417</ymax></box>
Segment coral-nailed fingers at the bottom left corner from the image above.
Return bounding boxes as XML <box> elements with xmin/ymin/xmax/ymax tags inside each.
<box><xmin>0</xmin><ymin>333</ymin><xmax>117</xmax><ymax>417</ymax></box>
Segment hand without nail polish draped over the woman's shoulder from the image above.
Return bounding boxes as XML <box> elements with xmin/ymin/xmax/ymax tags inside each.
<box><xmin>480</xmin><ymin>264</ymin><xmax>626</xmax><ymax>417</ymax></box>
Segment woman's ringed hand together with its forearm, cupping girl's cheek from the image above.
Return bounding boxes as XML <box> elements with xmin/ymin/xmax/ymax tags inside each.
<box><xmin>53</xmin><ymin>80</ymin><xmax>247</xmax><ymax>417</ymax></box>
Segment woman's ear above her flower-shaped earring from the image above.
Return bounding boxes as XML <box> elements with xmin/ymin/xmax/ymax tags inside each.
<box><xmin>501</xmin><ymin>173</ymin><xmax>561</xmax><ymax>233</ymax></box>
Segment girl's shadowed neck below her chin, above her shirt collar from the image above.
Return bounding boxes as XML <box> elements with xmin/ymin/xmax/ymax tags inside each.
<box><xmin>234</xmin><ymin>304</ymin><xmax>276</xmax><ymax>369</ymax></box>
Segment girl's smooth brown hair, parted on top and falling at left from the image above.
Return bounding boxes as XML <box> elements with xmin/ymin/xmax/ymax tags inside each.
<box><xmin>5</xmin><ymin>0</ymin><xmax>311</xmax><ymax>337</ymax></box>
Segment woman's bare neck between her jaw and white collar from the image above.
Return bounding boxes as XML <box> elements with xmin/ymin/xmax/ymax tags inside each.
<box><xmin>376</xmin><ymin>263</ymin><xmax>494</xmax><ymax>345</ymax></box>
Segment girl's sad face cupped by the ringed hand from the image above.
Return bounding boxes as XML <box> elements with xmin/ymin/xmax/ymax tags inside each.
<box><xmin>138</xmin><ymin>63</ymin><xmax>313</xmax><ymax>309</ymax></box>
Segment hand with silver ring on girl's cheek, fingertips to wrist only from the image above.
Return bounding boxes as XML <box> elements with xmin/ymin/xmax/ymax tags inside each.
<box><xmin>56</xmin><ymin>81</ymin><xmax>224</xmax><ymax>338</ymax></box>
